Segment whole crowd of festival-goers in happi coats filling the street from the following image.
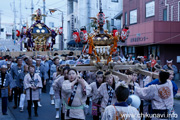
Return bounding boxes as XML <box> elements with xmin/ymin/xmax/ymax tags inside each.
<box><xmin>0</xmin><ymin>52</ymin><xmax>178</xmax><ymax>120</ymax></box>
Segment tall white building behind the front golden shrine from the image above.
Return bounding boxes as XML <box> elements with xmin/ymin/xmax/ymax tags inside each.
<box><xmin>67</xmin><ymin>0</ymin><xmax>123</xmax><ymax>41</ymax></box>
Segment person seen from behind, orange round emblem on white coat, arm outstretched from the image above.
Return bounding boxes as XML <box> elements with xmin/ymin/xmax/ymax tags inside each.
<box><xmin>135</xmin><ymin>71</ymin><xmax>174</xmax><ymax>120</ymax></box>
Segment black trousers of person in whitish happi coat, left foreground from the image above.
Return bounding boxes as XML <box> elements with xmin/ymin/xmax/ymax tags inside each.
<box><xmin>28</xmin><ymin>100</ymin><xmax>38</xmax><ymax>116</ymax></box>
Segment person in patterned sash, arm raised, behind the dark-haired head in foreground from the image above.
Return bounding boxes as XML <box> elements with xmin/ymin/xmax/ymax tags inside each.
<box><xmin>96</xmin><ymin>71</ymin><xmax>120</xmax><ymax>115</ymax></box>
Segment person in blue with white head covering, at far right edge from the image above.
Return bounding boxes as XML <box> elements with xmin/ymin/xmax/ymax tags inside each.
<box><xmin>163</xmin><ymin>59</ymin><xmax>178</xmax><ymax>74</ymax></box>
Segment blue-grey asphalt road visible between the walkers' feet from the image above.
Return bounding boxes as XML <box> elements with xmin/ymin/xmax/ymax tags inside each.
<box><xmin>6</xmin><ymin>81</ymin><xmax>180</xmax><ymax>120</ymax></box>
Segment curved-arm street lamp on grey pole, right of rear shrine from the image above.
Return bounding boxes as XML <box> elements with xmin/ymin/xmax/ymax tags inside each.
<box><xmin>49</xmin><ymin>8</ymin><xmax>64</xmax><ymax>50</ymax></box>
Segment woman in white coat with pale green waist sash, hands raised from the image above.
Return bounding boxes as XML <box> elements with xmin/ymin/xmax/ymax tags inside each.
<box><xmin>62</xmin><ymin>69</ymin><xmax>91</xmax><ymax>120</ymax></box>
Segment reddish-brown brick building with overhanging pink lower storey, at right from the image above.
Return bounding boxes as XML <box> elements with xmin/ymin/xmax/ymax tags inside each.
<box><xmin>123</xmin><ymin>0</ymin><xmax>180</xmax><ymax>68</ymax></box>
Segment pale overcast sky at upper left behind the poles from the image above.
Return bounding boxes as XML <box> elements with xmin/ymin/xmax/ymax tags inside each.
<box><xmin>0</xmin><ymin>0</ymin><xmax>67</xmax><ymax>26</ymax></box>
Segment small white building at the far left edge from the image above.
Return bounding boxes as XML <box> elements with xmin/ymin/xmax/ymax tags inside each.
<box><xmin>0</xmin><ymin>23</ymin><xmax>13</xmax><ymax>40</ymax></box>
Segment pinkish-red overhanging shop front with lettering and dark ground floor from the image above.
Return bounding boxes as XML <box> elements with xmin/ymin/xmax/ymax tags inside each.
<box><xmin>123</xmin><ymin>21</ymin><xmax>180</xmax><ymax>68</ymax></box>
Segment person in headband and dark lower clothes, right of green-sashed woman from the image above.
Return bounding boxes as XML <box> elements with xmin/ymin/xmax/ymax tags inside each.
<box><xmin>90</xmin><ymin>71</ymin><xmax>104</xmax><ymax>120</ymax></box>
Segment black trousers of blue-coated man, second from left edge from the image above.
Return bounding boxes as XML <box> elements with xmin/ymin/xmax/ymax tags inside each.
<box><xmin>13</xmin><ymin>87</ymin><xmax>22</xmax><ymax>106</ymax></box>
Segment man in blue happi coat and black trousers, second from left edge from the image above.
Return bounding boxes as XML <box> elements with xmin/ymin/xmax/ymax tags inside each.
<box><xmin>11</xmin><ymin>57</ymin><xmax>24</xmax><ymax>109</ymax></box>
